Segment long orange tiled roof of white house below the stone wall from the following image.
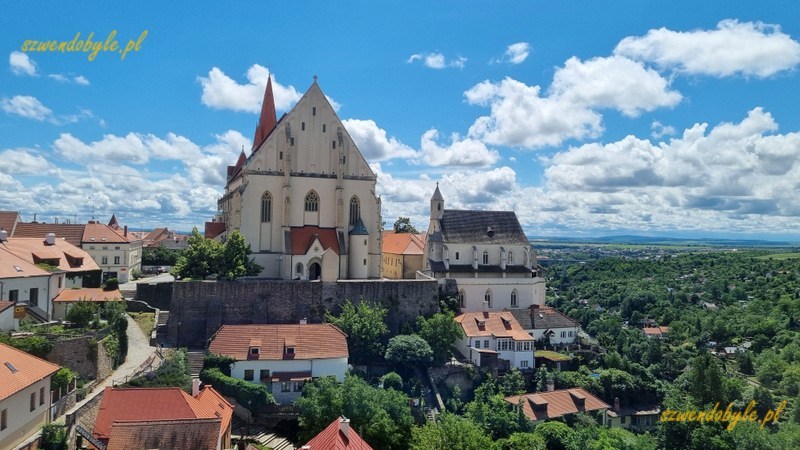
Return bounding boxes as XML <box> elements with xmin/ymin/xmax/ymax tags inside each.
<box><xmin>208</xmin><ymin>323</ymin><xmax>349</xmax><ymax>361</ymax></box>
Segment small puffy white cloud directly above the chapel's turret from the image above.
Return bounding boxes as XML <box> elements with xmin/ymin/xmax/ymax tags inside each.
<box><xmin>420</xmin><ymin>128</ymin><xmax>500</xmax><ymax>167</ymax></box>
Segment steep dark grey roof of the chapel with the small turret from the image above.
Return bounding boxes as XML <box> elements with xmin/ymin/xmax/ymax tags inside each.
<box><xmin>439</xmin><ymin>209</ymin><xmax>530</xmax><ymax>245</ymax></box>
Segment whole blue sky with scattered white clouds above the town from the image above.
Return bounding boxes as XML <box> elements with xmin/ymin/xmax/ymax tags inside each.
<box><xmin>0</xmin><ymin>1</ymin><xmax>800</xmax><ymax>239</ymax></box>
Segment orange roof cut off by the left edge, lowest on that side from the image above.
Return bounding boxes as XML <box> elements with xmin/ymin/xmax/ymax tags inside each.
<box><xmin>0</xmin><ymin>344</ymin><xmax>61</xmax><ymax>401</ymax></box>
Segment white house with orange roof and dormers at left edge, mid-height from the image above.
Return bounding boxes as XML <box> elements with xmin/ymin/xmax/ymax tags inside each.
<box><xmin>0</xmin><ymin>232</ymin><xmax>100</xmax><ymax>321</ymax></box>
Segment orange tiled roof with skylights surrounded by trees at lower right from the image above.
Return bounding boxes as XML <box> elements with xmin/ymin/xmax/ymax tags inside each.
<box><xmin>505</xmin><ymin>388</ymin><xmax>610</xmax><ymax>421</ymax></box>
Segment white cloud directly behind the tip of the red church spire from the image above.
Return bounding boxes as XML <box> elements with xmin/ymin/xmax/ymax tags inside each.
<box><xmin>197</xmin><ymin>64</ymin><xmax>302</xmax><ymax>113</ymax></box>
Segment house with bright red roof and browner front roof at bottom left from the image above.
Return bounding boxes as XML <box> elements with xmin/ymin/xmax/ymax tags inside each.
<box><xmin>92</xmin><ymin>380</ymin><xmax>233</xmax><ymax>450</ymax></box>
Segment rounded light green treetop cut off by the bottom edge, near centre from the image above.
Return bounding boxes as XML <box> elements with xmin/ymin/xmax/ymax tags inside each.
<box><xmin>409</xmin><ymin>413</ymin><xmax>497</xmax><ymax>450</ymax></box>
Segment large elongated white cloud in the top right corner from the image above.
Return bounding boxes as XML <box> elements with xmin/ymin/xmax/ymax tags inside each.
<box><xmin>614</xmin><ymin>20</ymin><xmax>800</xmax><ymax>78</ymax></box>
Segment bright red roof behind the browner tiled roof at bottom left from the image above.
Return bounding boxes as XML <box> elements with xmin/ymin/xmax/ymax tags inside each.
<box><xmin>92</xmin><ymin>386</ymin><xmax>233</xmax><ymax>448</ymax></box>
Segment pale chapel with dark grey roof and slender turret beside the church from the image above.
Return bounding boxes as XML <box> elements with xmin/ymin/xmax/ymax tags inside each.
<box><xmin>423</xmin><ymin>184</ymin><xmax>545</xmax><ymax>312</ymax></box>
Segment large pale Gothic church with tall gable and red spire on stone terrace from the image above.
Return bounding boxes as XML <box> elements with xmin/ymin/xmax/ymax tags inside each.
<box><xmin>218</xmin><ymin>77</ymin><xmax>382</xmax><ymax>281</ymax></box>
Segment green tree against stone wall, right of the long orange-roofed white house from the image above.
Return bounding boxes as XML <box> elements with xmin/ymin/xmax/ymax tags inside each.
<box><xmin>325</xmin><ymin>299</ymin><xmax>389</xmax><ymax>364</ymax></box>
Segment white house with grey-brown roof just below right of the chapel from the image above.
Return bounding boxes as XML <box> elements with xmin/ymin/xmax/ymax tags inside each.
<box><xmin>511</xmin><ymin>305</ymin><xmax>581</xmax><ymax>344</ymax></box>
